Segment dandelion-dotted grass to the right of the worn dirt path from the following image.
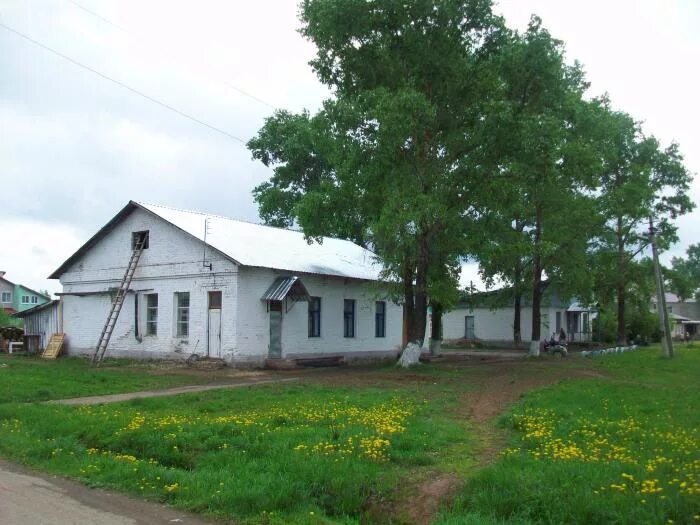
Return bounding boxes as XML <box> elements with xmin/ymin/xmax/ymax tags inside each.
<box><xmin>437</xmin><ymin>348</ymin><xmax>700</xmax><ymax>525</ymax></box>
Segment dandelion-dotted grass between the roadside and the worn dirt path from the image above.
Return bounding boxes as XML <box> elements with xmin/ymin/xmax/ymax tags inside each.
<box><xmin>0</xmin><ymin>384</ymin><xmax>468</xmax><ymax>523</ymax></box>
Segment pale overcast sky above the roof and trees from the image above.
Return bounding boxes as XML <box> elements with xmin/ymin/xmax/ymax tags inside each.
<box><xmin>0</xmin><ymin>0</ymin><xmax>700</xmax><ymax>292</ymax></box>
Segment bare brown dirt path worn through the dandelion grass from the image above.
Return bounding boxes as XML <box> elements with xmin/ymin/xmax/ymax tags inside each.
<box><xmin>314</xmin><ymin>352</ymin><xmax>604</xmax><ymax>525</ymax></box>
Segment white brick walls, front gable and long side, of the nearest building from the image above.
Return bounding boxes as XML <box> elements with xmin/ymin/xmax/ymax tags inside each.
<box><xmin>61</xmin><ymin>210</ymin><xmax>402</xmax><ymax>363</ymax></box>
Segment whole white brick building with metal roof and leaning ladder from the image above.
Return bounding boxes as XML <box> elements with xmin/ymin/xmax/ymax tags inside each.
<box><xmin>50</xmin><ymin>201</ymin><xmax>402</xmax><ymax>363</ymax></box>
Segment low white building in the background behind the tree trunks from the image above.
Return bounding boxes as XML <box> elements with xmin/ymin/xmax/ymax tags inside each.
<box><xmin>443</xmin><ymin>283</ymin><xmax>593</xmax><ymax>345</ymax></box>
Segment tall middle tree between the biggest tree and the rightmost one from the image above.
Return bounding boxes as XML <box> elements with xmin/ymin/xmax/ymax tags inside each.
<box><xmin>480</xmin><ymin>17</ymin><xmax>600</xmax><ymax>354</ymax></box>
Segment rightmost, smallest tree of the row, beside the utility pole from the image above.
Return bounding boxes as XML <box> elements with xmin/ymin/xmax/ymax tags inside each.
<box><xmin>594</xmin><ymin>99</ymin><xmax>694</xmax><ymax>344</ymax></box>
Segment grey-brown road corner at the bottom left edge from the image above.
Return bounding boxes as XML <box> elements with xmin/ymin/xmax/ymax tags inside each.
<box><xmin>0</xmin><ymin>460</ymin><xmax>221</xmax><ymax>525</ymax></box>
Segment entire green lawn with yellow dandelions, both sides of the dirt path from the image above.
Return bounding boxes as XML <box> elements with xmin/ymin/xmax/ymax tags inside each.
<box><xmin>0</xmin><ymin>348</ymin><xmax>700</xmax><ymax>525</ymax></box>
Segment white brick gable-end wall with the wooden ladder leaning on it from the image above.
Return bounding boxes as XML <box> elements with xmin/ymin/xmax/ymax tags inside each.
<box><xmin>61</xmin><ymin>210</ymin><xmax>238</xmax><ymax>358</ymax></box>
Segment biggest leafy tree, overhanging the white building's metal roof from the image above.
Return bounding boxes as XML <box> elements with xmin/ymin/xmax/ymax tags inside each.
<box><xmin>249</xmin><ymin>0</ymin><xmax>504</xmax><ymax>348</ymax></box>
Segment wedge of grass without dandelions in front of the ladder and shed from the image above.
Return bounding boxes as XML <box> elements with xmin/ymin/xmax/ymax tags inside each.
<box><xmin>0</xmin><ymin>356</ymin><xmax>205</xmax><ymax>403</ymax></box>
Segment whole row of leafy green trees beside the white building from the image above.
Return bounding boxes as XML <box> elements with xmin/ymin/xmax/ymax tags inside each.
<box><xmin>248</xmin><ymin>0</ymin><xmax>692</xmax><ymax>347</ymax></box>
